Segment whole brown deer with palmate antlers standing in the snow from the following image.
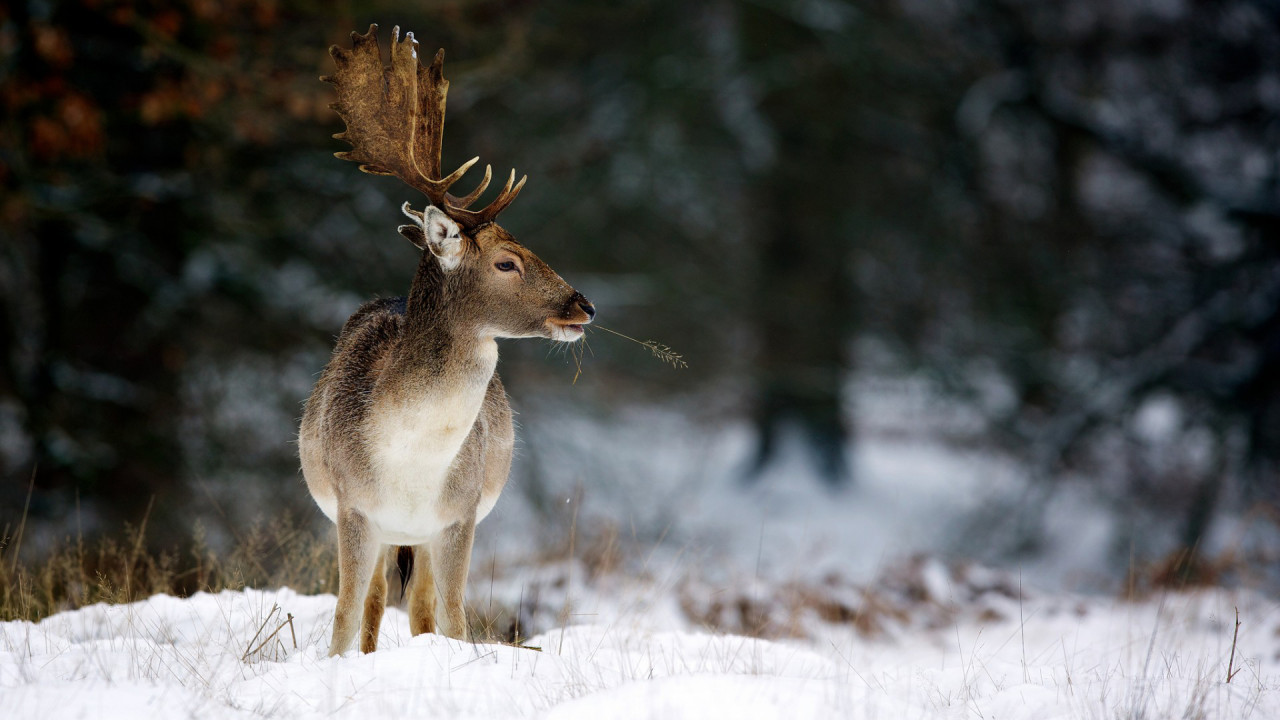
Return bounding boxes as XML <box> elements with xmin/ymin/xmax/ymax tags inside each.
<box><xmin>298</xmin><ymin>24</ymin><xmax>595</xmax><ymax>656</ymax></box>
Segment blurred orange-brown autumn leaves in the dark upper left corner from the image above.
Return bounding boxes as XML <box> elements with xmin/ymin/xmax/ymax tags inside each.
<box><xmin>0</xmin><ymin>0</ymin><xmax>328</xmax><ymax>166</ymax></box>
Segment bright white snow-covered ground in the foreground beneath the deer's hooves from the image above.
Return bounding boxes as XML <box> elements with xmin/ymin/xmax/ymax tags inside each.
<box><xmin>0</xmin><ymin>579</ymin><xmax>1280</xmax><ymax>720</ymax></box>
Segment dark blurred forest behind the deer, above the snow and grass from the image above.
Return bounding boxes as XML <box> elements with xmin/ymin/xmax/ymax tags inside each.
<box><xmin>0</xmin><ymin>0</ymin><xmax>1280</xmax><ymax>584</ymax></box>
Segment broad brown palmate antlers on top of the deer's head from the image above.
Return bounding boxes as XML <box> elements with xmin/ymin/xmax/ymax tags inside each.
<box><xmin>320</xmin><ymin>24</ymin><xmax>527</xmax><ymax>229</ymax></box>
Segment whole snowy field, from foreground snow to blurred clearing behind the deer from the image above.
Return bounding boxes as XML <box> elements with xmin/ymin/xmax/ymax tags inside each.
<box><xmin>10</xmin><ymin>392</ymin><xmax>1280</xmax><ymax>720</ymax></box>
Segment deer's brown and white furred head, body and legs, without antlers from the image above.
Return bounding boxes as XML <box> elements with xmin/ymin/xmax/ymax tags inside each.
<box><xmin>298</xmin><ymin>208</ymin><xmax>594</xmax><ymax>655</ymax></box>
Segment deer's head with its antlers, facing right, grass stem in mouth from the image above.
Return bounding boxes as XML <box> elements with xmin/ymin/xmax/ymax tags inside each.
<box><xmin>320</xmin><ymin>24</ymin><xmax>595</xmax><ymax>342</ymax></box>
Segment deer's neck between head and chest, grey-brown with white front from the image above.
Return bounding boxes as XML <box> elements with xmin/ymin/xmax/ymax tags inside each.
<box><xmin>394</xmin><ymin>252</ymin><xmax>498</xmax><ymax>387</ymax></box>
